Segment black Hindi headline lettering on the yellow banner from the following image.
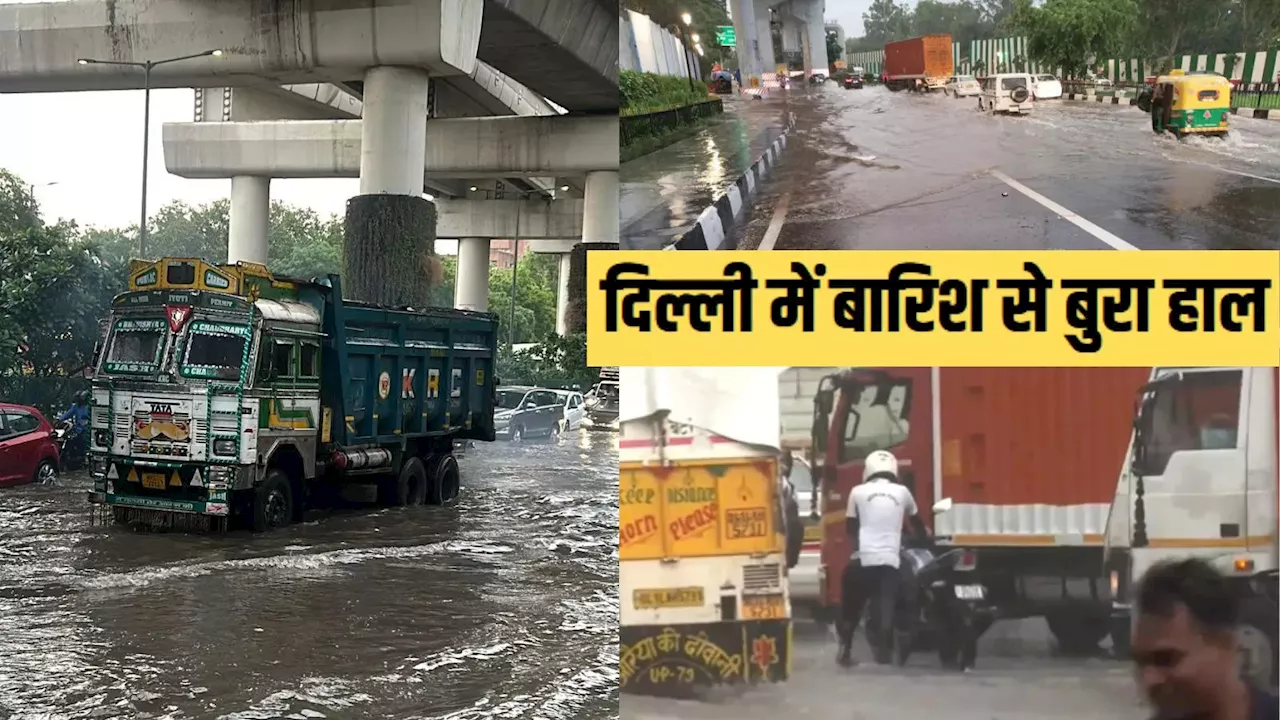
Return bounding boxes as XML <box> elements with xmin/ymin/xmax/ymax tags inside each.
<box><xmin>600</xmin><ymin>261</ymin><xmax>1272</xmax><ymax>352</ymax></box>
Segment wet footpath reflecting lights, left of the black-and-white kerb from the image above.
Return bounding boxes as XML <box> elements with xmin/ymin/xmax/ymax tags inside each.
<box><xmin>618</xmin><ymin>97</ymin><xmax>786</xmax><ymax>250</ymax></box>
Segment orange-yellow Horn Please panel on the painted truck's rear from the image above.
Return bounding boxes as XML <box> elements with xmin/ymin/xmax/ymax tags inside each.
<box><xmin>618</xmin><ymin>459</ymin><xmax>782</xmax><ymax>560</ymax></box>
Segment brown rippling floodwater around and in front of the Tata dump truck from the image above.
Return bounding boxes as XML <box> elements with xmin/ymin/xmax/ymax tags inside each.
<box><xmin>0</xmin><ymin>432</ymin><xmax>618</xmax><ymax>720</ymax></box>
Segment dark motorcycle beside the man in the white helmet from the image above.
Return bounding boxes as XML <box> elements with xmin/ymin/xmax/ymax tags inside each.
<box><xmin>867</xmin><ymin>498</ymin><xmax>996</xmax><ymax>671</ymax></box>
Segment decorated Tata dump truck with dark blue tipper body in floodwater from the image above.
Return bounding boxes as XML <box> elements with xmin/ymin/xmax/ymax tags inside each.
<box><xmin>88</xmin><ymin>258</ymin><xmax>498</xmax><ymax>530</ymax></box>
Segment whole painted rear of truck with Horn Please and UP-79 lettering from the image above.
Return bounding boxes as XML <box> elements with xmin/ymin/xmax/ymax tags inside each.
<box><xmin>618</xmin><ymin>368</ymin><xmax>791</xmax><ymax>696</ymax></box>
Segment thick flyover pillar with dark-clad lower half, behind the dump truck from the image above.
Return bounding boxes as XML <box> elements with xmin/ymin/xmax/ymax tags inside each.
<box><xmin>343</xmin><ymin>67</ymin><xmax>438</xmax><ymax>307</ymax></box>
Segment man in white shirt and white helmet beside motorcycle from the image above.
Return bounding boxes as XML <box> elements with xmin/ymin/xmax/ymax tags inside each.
<box><xmin>837</xmin><ymin>450</ymin><xmax>928</xmax><ymax>666</ymax></box>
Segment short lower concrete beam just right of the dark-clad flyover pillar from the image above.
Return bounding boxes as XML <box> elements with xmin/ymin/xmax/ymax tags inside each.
<box><xmin>435</xmin><ymin>199</ymin><xmax>582</xmax><ymax>239</ymax></box>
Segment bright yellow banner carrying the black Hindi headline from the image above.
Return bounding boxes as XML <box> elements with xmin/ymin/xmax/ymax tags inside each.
<box><xmin>588</xmin><ymin>250</ymin><xmax>1280</xmax><ymax>368</ymax></box>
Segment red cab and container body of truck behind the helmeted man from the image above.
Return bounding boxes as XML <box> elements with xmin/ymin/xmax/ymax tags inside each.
<box><xmin>822</xmin><ymin>368</ymin><xmax>1151</xmax><ymax>606</ymax></box>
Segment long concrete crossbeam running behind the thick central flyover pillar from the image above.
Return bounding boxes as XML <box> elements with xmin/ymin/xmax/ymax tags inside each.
<box><xmin>164</xmin><ymin>115</ymin><xmax>618</xmax><ymax>178</ymax></box>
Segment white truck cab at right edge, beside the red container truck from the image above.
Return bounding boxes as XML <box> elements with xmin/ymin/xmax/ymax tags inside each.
<box><xmin>1106</xmin><ymin>368</ymin><xmax>1280</xmax><ymax>687</ymax></box>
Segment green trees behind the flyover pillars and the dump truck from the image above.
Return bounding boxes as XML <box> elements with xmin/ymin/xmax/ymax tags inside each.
<box><xmin>0</xmin><ymin>170</ymin><xmax>576</xmax><ymax>411</ymax></box>
